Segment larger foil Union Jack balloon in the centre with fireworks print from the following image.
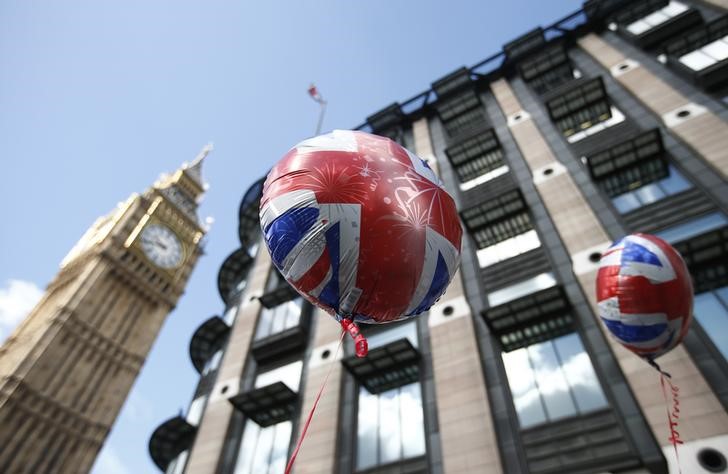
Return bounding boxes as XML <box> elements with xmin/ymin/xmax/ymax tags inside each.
<box><xmin>260</xmin><ymin>130</ymin><xmax>462</xmax><ymax>323</ymax></box>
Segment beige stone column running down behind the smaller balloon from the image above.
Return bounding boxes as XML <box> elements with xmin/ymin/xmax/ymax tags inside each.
<box><xmin>491</xmin><ymin>78</ymin><xmax>728</xmax><ymax>456</ymax></box>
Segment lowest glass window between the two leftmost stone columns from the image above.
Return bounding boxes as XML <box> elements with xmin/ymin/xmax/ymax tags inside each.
<box><xmin>234</xmin><ymin>421</ymin><xmax>292</xmax><ymax>474</ymax></box>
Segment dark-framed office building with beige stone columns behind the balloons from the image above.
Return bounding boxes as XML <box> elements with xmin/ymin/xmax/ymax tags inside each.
<box><xmin>149</xmin><ymin>0</ymin><xmax>728</xmax><ymax>474</ymax></box>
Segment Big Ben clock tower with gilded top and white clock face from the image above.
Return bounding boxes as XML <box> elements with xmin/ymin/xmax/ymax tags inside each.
<box><xmin>0</xmin><ymin>145</ymin><xmax>211</xmax><ymax>474</ymax></box>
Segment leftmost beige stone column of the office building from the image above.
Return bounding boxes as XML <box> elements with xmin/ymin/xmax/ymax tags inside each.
<box><xmin>186</xmin><ymin>247</ymin><xmax>271</xmax><ymax>474</ymax></box>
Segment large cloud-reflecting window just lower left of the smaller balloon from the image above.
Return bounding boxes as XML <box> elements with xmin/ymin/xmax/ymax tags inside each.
<box><xmin>502</xmin><ymin>333</ymin><xmax>607</xmax><ymax>428</ymax></box>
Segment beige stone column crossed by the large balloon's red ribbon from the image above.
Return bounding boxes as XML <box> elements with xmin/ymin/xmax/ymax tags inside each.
<box><xmin>292</xmin><ymin>308</ymin><xmax>344</xmax><ymax>474</ymax></box>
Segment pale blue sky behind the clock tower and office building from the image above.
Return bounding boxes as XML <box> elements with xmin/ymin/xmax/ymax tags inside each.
<box><xmin>0</xmin><ymin>0</ymin><xmax>580</xmax><ymax>474</ymax></box>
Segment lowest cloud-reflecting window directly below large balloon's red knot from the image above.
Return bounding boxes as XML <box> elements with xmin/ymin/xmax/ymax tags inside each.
<box><xmin>356</xmin><ymin>382</ymin><xmax>425</xmax><ymax>470</ymax></box>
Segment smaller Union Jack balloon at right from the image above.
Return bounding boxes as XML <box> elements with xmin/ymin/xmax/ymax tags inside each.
<box><xmin>597</xmin><ymin>234</ymin><xmax>693</xmax><ymax>361</ymax></box>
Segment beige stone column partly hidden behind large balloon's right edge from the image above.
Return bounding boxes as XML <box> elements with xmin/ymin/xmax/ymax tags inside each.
<box><xmin>413</xmin><ymin>115</ymin><xmax>502</xmax><ymax>474</ymax></box>
